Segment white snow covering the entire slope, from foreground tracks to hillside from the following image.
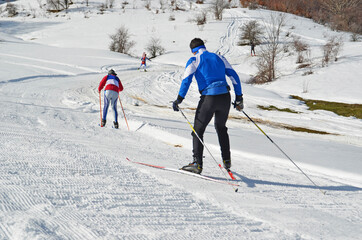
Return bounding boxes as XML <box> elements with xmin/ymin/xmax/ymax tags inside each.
<box><xmin>0</xmin><ymin>0</ymin><xmax>362</xmax><ymax>240</ymax></box>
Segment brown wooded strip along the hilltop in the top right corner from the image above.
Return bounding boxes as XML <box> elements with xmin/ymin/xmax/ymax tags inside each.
<box><xmin>239</xmin><ymin>0</ymin><xmax>362</xmax><ymax>34</ymax></box>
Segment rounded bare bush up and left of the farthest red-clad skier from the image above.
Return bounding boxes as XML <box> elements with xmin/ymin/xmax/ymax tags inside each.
<box><xmin>109</xmin><ymin>26</ymin><xmax>136</xmax><ymax>54</ymax></box>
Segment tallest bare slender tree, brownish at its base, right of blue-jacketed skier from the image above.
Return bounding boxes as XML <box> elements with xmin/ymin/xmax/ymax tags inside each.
<box><xmin>253</xmin><ymin>14</ymin><xmax>286</xmax><ymax>83</ymax></box>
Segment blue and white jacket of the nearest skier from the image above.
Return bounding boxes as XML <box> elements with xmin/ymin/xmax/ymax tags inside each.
<box><xmin>179</xmin><ymin>46</ymin><xmax>242</xmax><ymax>98</ymax></box>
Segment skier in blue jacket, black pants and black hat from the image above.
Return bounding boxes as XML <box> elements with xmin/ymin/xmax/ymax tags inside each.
<box><xmin>173</xmin><ymin>38</ymin><xmax>244</xmax><ymax>174</ymax></box>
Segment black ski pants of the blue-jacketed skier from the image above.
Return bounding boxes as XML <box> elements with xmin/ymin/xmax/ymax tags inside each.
<box><xmin>192</xmin><ymin>93</ymin><xmax>231</xmax><ymax>166</ymax></box>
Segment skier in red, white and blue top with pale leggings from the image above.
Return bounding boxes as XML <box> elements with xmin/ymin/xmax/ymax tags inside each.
<box><xmin>98</xmin><ymin>69</ymin><xmax>123</xmax><ymax>128</ymax></box>
